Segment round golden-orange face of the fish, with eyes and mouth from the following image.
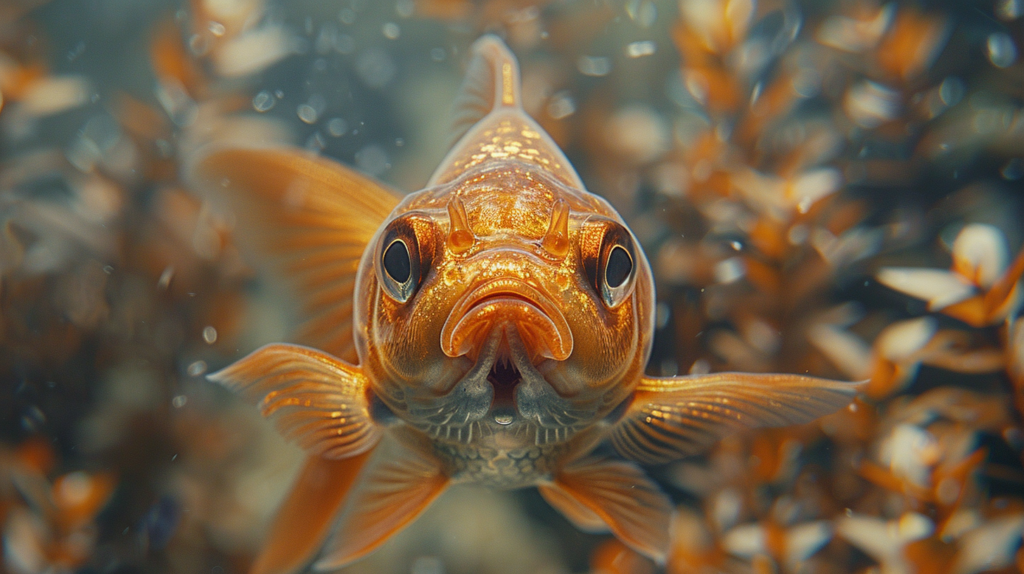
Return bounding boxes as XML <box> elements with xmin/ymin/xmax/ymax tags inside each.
<box><xmin>355</xmin><ymin>160</ymin><xmax>653</xmax><ymax>444</ymax></box>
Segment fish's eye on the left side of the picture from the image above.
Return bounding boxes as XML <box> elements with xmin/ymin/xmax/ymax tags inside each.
<box><xmin>376</xmin><ymin>215</ymin><xmax>433</xmax><ymax>303</ymax></box>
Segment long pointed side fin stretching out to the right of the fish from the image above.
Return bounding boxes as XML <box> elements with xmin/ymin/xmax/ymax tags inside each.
<box><xmin>611</xmin><ymin>372</ymin><xmax>861</xmax><ymax>463</ymax></box>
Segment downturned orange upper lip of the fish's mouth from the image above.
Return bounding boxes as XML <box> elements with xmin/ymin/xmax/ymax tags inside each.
<box><xmin>441</xmin><ymin>278</ymin><xmax>572</xmax><ymax>364</ymax></box>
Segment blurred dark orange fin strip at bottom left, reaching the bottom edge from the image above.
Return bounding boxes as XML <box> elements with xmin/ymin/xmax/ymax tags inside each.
<box><xmin>249</xmin><ymin>451</ymin><xmax>370</xmax><ymax>574</ymax></box>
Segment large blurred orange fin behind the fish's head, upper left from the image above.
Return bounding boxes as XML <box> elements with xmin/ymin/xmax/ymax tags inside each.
<box><xmin>189</xmin><ymin>148</ymin><xmax>398</xmax><ymax>362</ymax></box>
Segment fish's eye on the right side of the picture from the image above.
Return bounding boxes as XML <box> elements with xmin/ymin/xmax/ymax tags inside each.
<box><xmin>580</xmin><ymin>220</ymin><xmax>636</xmax><ymax>309</ymax></box>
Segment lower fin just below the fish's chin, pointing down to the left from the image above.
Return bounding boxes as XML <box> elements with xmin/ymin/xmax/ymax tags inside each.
<box><xmin>313</xmin><ymin>441</ymin><xmax>449</xmax><ymax>571</ymax></box>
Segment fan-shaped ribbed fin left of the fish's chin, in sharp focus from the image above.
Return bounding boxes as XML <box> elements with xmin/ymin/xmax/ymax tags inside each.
<box><xmin>209</xmin><ymin>344</ymin><xmax>381</xmax><ymax>458</ymax></box>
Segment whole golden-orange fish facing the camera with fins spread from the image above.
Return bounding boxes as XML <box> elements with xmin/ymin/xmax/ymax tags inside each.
<box><xmin>189</xmin><ymin>36</ymin><xmax>860</xmax><ymax>574</ymax></box>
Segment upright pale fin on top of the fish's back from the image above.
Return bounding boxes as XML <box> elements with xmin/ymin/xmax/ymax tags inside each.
<box><xmin>449</xmin><ymin>35</ymin><xmax>522</xmax><ymax>145</ymax></box>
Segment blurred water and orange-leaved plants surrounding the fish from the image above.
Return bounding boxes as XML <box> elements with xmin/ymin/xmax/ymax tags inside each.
<box><xmin>0</xmin><ymin>0</ymin><xmax>1024</xmax><ymax>574</ymax></box>
